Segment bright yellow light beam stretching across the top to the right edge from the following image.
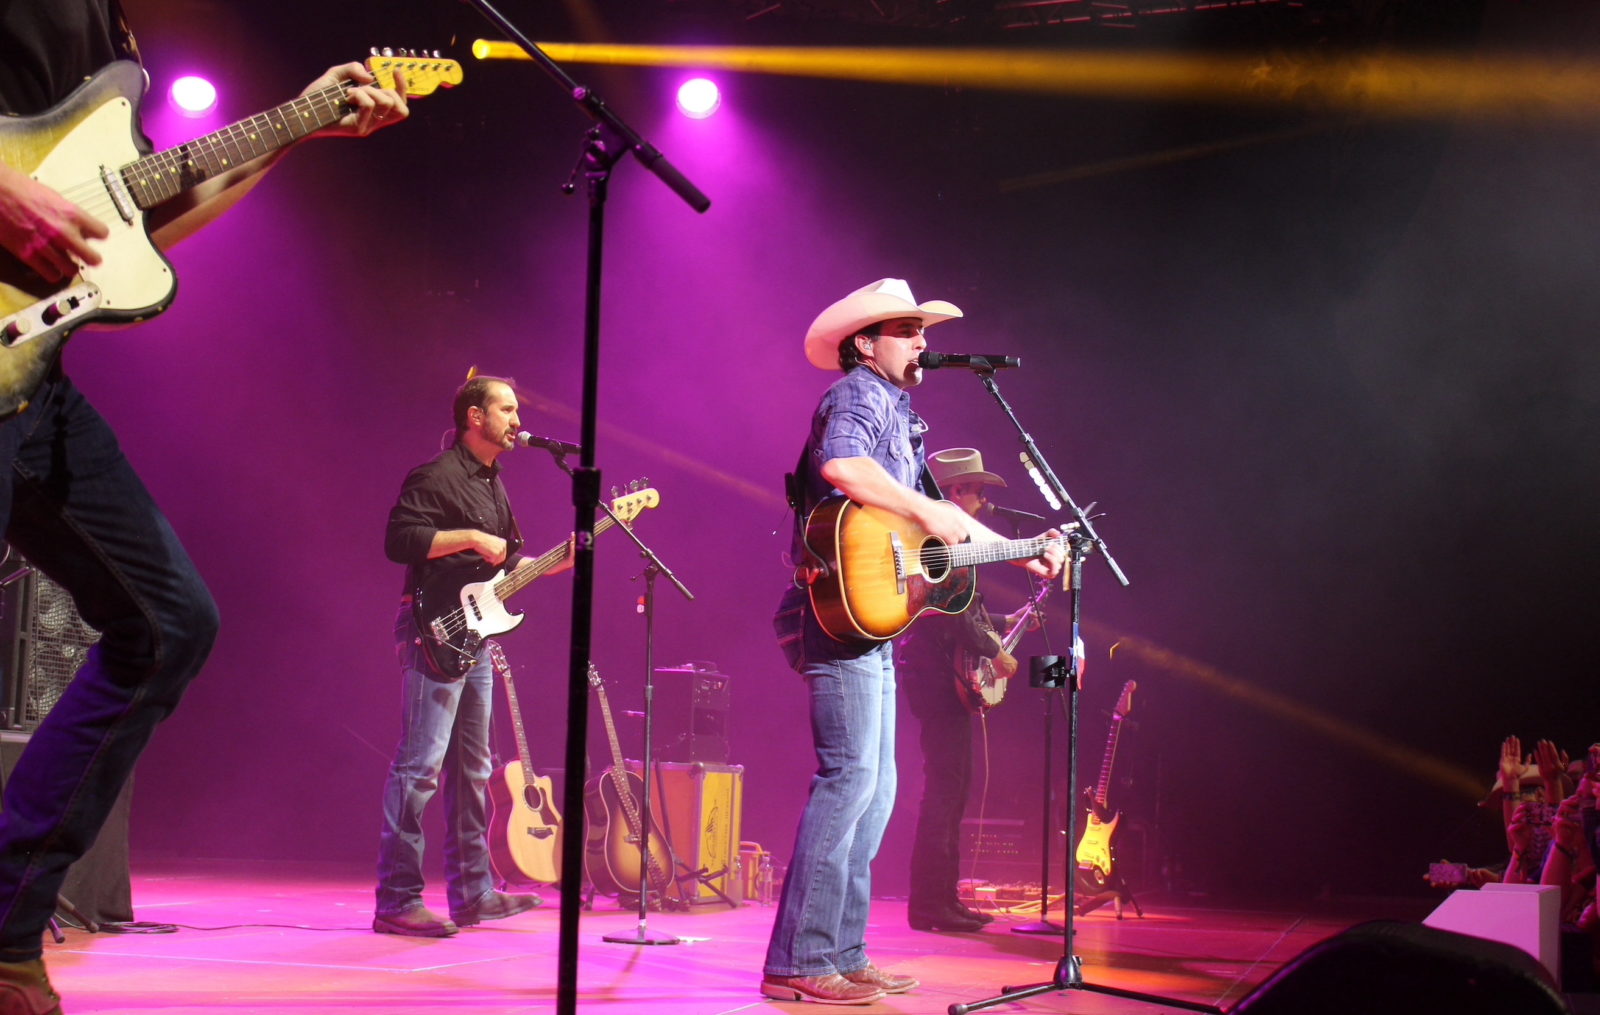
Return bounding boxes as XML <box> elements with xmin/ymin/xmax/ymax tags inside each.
<box><xmin>472</xmin><ymin>38</ymin><xmax>1600</xmax><ymax>117</ymax></box>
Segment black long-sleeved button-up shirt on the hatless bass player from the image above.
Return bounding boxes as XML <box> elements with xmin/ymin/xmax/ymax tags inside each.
<box><xmin>384</xmin><ymin>440</ymin><xmax>522</xmax><ymax>594</ymax></box>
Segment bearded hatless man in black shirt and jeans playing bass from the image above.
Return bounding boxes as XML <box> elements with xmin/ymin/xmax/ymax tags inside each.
<box><xmin>373</xmin><ymin>375</ymin><xmax>571</xmax><ymax>938</ymax></box>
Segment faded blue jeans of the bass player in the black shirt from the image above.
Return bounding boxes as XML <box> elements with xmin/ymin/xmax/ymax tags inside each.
<box><xmin>376</xmin><ymin>607</ymin><xmax>494</xmax><ymax>916</ymax></box>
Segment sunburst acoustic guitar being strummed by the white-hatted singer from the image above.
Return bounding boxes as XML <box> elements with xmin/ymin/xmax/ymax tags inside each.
<box><xmin>802</xmin><ymin>498</ymin><xmax>1059</xmax><ymax>642</ymax></box>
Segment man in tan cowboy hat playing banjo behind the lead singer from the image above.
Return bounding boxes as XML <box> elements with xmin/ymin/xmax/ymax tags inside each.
<box><xmin>894</xmin><ymin>448</ymin><xmax>1034</xmax><ymax>932</ymax></box>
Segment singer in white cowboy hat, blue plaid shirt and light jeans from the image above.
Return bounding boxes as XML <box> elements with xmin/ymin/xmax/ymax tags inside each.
<box><xmin>762</xmin><ymin>279</ymin><xmax>1061</xmax><ymax>1004</ymax></box>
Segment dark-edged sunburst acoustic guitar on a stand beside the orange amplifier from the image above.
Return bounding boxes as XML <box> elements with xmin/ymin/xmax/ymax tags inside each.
<box><xmin>584</xmin><ymin>663</ymin><xmax>672</xmax><ymax>903</ymax></box>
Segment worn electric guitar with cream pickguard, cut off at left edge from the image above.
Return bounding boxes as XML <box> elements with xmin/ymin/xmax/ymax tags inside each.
<box><xmin>0</xmin><ymin>56</ymin><xmax>461</xmax><ymax>419</ymax></box>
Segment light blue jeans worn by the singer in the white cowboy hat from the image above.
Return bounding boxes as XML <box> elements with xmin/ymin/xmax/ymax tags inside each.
<box><xmin>763</xmin><ymin>579</ymin><xmax>894</xmax><ymax>977</ymax></box>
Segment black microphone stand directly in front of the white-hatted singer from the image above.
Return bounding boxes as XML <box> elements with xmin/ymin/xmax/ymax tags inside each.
<box><xmin>947</xmin><ymin>370</ymin><xmax>1222</xmax><ymax>1015</ymax></box>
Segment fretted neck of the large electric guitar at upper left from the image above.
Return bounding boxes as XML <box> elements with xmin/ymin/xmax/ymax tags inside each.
<box><xmin>122</xmin><ymin>85</ymin><xmax>350</xmax><ymax>210</ymax></box>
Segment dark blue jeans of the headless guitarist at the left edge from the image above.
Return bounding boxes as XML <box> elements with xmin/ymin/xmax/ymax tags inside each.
<box><xmin>0</xmin><ymin>376</ymin><xmax>218</xmax><ymax>962</ymax></box>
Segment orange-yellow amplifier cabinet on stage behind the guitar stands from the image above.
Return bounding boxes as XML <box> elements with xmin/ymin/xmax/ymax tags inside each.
<box><xmin>627</xmin><ymin>760</ymin><xmax>744</xmax><ymax>905</ymax></box>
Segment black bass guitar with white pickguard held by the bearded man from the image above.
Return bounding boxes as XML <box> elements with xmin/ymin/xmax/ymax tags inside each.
<box><xmin>411</xmin><ymin>480</ymin><xmax>661</xmax><ymax>680</ymax></box>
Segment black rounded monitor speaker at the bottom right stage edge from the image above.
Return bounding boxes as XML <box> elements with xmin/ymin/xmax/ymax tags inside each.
<box><xmin>1230</xmin><ymin>921</ymin><xmax>1570</xmax><ymax>1015</ymax></box>
